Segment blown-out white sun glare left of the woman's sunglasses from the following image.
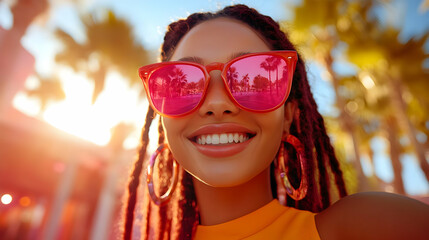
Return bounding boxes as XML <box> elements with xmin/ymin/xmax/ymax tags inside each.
<box><xmin>14</xmin><ymin>66</ymin><xmax>147</xmax><ymax>149</ymax></box>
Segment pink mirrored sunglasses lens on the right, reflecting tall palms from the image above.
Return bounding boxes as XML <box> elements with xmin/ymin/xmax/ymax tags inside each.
<box><xmin>226</xmin><ymin>55</ymin><xmax>289</xmax><ymax>111</ymax></box>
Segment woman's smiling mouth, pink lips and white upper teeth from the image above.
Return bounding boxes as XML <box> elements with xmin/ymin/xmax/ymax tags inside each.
<box><xmin>188</xmin><ymin>123</ymin><xmax>256</xmax><ymax>157</ymax></box>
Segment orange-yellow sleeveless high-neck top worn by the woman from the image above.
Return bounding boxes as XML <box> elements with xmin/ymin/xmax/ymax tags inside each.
<box><xmin>194</xmin><ymin>199</ymin><xmax>320</xmax><ymax>240</ymax></box>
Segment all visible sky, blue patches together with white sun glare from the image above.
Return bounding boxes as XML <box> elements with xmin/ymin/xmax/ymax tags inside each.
<box><xmin>0</xmin><ymin>0</ymin><xmax>429</xmax><ymax>194</ymax></box>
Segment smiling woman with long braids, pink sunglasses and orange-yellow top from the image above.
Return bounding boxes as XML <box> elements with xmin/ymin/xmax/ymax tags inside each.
<box><xmin>124</xmin><ymin>5</ymin><xmax>429</xmax><ymax>239</ymax></box>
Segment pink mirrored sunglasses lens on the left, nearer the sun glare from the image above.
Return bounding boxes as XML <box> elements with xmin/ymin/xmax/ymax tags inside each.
<box><xmin>148</xmin><ymin>64</ymin><xmax>205</xmax><ymax>116</ymax></box>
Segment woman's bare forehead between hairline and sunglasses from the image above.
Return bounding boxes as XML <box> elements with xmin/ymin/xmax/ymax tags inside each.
<box><xmin>171</xmin><ymin>18</ymin><xmax>270</xmax><ymax>63</ymax></box>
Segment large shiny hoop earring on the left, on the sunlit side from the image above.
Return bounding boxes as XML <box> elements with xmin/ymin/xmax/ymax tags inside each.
<box><xmin>146</xmin><ymin>144</ymin><xmax>179</xmax><ymax>206</ymax></box>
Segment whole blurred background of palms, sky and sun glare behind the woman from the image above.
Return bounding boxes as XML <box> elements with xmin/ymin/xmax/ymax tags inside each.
<box><xmin>0</xmin><ymin>0</ymin><xmax>429</xmax><ymax>240</ymax></box>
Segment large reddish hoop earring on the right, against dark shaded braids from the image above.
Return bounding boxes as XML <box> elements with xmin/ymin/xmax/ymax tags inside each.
<box><xmin>276</xmin><ymin>134</ymin><xmax>308</xmax><ymax>201</ymax></box>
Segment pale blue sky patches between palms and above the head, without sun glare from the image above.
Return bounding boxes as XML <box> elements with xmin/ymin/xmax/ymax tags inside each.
<box><xmin>0</xmin><ymin>0</ymin><xmax>429</xmax><ymax>194</ymax></box>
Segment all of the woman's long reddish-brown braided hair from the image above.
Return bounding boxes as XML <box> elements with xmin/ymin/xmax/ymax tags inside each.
<box><xmin>123</xmin><ymin>4</ymin><xmax>347</xmax><ymax>240</ymax></box>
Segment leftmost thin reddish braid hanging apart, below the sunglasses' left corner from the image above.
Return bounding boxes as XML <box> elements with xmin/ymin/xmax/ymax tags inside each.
<box><xmin>123</xmin><ymin>106</ymin><xmax>154</xmax><ymax>240</ymax></box>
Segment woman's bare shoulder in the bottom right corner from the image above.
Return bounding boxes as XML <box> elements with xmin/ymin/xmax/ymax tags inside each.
<box><xmin>316</xmin><ymin>192</ymin><xmax>429</xmax><ymax>239</ymax></box>
